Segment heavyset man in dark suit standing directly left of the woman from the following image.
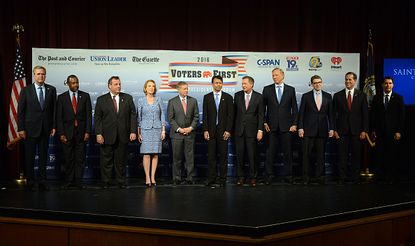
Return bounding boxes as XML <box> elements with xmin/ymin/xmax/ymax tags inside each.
<box><xmin>94</xmin><ymin>76</ymin><xmax>137</xmax><ymax>189</ymax></box>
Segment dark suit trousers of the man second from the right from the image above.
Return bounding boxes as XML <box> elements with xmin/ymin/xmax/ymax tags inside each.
<box><xmin>337</xmin><ymin>134</ymin><xmax>362</xmax><ymax>181</ymax></box>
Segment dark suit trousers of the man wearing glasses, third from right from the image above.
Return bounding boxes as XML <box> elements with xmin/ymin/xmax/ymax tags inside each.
<box><xmin>303</xmin><ymin>137</ymin><xmax>326</xmax><ymax>181</ymax></box>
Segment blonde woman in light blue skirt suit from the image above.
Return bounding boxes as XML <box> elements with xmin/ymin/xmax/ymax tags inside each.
<box><xmin>137</xmin><ymin>80</ymin><xmax>166</xmax><ymax>187</ymax></box>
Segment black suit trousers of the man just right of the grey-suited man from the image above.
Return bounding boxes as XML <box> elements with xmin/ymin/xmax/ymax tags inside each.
<box><xmin>208</xmin><ymin>131</ymin><xmax>228</xmax><ymax>182</ymax></box>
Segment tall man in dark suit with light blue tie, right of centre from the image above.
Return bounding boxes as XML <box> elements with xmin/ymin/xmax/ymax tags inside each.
<box><xmin>262</xmin><ymin>68</ymin><xmax>298</xmax><ymax>184</ymax></box>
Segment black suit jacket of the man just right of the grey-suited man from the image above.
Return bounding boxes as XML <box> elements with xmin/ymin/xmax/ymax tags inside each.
<box><xmin>203</xmin><ymin>91</ymin><xmax>233</xmax><ymax>138</ymax></box>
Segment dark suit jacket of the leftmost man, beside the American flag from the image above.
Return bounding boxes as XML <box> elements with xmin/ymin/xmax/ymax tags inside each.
<box><xmin>17</xmin><ymin>83</ymin><xmax>56</xmax><ymax>137</ymax></box>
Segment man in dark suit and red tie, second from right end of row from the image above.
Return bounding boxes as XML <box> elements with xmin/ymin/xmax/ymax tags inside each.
<box><xmin>333</xmin><ymin>72</ymin><xmax>369</xmax><ymax>184</ymax></box>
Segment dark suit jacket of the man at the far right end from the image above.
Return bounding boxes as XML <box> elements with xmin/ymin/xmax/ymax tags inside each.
<box><xmin>370</xmin><ymin>92</ymin><xmax>405</xmax><ymax>137</ymax></box>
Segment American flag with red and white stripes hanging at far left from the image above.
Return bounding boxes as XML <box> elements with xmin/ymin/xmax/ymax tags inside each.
<box><xmin>7</xmin><ymin>40</ymin><xmax>26</xmax><ymax>149</ymax></box>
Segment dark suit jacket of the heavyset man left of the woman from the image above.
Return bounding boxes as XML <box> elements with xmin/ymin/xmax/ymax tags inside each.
<box><xmin>94</xmin><ymin>93</ymin><xmax>137</xmax><ymax>144</ymax></box>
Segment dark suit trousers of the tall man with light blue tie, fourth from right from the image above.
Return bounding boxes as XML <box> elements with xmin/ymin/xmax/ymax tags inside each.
<box><xmin>265</xmin><ymin>131</ymin><xmax>293</xmax><ymax>178</ymax></box>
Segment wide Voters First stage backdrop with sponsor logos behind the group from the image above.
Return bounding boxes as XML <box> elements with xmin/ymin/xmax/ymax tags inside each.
<box><xmin>32</xmin><ymin>48</ymin><xmax>360</xmax><ymax>179</ymax></box>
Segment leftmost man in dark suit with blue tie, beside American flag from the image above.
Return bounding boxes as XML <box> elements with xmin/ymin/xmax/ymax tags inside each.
<box><xmin>17</xmin><ymin>66</ymin><xmax>56</xmax><ymax>190</ymax></box>
